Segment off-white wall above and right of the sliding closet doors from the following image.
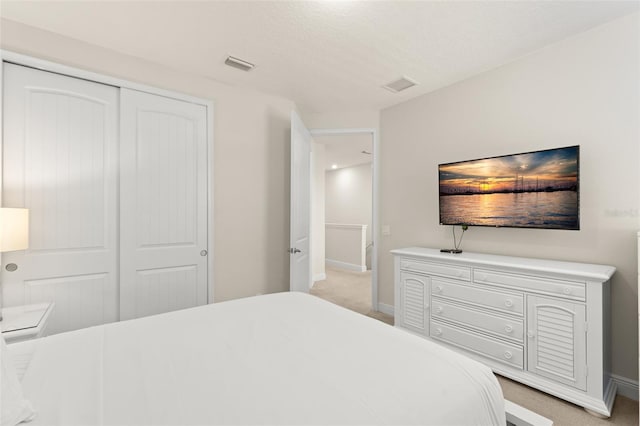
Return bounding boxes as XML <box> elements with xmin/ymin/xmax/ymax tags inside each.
<box><xmin>0</xmin><ymin>19</ymin><xmax>295</xmax><ymax>301</ymax></box>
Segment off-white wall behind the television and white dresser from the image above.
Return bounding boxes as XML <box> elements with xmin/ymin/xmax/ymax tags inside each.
<box><xmin>379</xmin><ymin>14</ymin><xmax>640</xmax><ymax>380</ymax></box>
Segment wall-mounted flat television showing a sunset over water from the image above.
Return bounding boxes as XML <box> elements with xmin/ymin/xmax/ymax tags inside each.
<box><xmin>438</xmin><ymin>145</ymin><xmax>580</xmax><ymax>230</ymax></box>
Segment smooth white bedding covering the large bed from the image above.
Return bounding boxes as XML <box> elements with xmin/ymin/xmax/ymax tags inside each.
<box><xmin>12</xmin><ymin>293</ymin><xmax>506</xmax><ymax>426</ymax></box>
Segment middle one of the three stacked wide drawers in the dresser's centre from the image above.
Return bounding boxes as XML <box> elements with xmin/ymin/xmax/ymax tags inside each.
<box><xmin>431</xmin><ymin>297</ymin><xmax>524</xmax><ymax>343</ymax></box>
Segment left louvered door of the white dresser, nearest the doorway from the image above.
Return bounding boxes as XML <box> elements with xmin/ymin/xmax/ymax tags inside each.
<box><xmin>400</xmin><ymin>272</ymin><xmax>430</xmax><ymax>334</ymax></box>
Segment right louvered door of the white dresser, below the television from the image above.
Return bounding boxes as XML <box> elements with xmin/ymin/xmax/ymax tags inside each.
<box><xmin>527</xmin><ymin>295</ymin><xmax>587</xmax><ymax>390</ymax></box>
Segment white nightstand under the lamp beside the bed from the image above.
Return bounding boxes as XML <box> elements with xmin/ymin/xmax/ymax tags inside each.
<box><xmin>0</xmin><ymin>303</ymin><xmax>54</xmax><ymax>343</ymax></box>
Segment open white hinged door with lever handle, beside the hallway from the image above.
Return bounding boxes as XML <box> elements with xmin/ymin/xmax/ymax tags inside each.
<box><xmin>289</xmin><ymin>111</ymin><xmax>313</xmax><ymax>292</ymax></box>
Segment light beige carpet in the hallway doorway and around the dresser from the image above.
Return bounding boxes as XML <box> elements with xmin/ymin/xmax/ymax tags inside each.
<box><xmin>310</xmin><ymin>268</ymin><xmax>638</xmax><ymax>426</ymax></box>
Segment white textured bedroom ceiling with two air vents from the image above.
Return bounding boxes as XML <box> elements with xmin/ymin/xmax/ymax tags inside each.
<box><xmin>0</xmin><ymin>0</ymin><xmax>638</xmax><ymax>112</ymax></box>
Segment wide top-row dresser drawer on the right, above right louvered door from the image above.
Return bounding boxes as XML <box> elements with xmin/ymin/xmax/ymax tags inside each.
<box><xmin>473</xmin><ymin>269</ymin><xmax>586</xmax><ymax>301</ymax></box>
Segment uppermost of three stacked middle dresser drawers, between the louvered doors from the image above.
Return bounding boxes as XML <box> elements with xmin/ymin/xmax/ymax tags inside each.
<box><xmin>431</xmin><ymin>279</ymin><xmax>524</xmax><ymax>315</ymax></box>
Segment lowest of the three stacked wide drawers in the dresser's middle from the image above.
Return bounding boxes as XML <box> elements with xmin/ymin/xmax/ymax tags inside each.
<box><xmin>430</xmin><ymin>321</ymin><xmax>524</xmax><ymax>370</ymax></box>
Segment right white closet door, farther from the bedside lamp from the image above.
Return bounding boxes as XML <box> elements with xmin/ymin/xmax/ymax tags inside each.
<box><xmin>120</xmin><ymin>89</ymin><xmax>208</xmax><ymax>319</ymax></box>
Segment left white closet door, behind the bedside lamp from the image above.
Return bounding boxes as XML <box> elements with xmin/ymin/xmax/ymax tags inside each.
<box><xmin>0</xmin><ymin>63</ymin><xmax>118</xmax><ymax>334</ymax></box>
